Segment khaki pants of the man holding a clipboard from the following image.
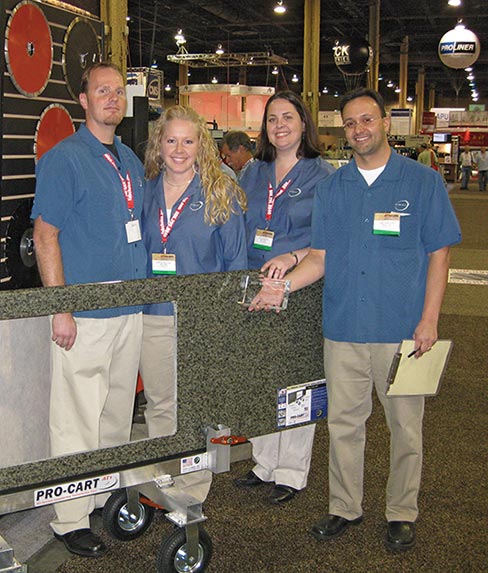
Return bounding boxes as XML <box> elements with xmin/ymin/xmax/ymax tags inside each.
<box><xmin>324</xmin><ymin>339</ymin><xmax>424</xmax><ymax>521</ymax></box>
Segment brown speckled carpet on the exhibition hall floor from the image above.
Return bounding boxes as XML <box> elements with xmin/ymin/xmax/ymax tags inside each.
<box><xmin>38</xmin><ymin>189</ymin><xmax>488</xmax><ymax>573</ymax></box>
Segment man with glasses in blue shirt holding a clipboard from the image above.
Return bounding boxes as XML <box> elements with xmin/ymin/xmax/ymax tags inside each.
<box><xmin>251</xmin><ymin>88</ymin><xmax>461</xmax><ymax>550</ymax></box>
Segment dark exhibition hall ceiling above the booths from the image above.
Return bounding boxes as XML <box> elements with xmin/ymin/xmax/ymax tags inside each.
<box><xmin>128</xmin><ymin>0</ymin><xmax>488</xmax><ymax>103</ymax></box>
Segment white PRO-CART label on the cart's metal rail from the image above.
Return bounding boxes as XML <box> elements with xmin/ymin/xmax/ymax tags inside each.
<box><xmin>34</xmin><ymin>473</ymin><xmax>120</xmax><ymax>507</ymax></box>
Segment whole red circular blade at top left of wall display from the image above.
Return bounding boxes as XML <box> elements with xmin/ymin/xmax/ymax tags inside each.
<box><xmin>5</xmin><ymin>1</ymin><xmax>53</xmax><ymax>97</ymax></box>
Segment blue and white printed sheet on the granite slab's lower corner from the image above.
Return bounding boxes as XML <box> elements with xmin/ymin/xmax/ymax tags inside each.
<box><xmin>277</xmin><ymin>379</ymin><xmax>327</xmax><ymax>428</ymax></box>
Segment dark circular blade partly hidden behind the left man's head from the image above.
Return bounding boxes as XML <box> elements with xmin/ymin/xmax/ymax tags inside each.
<box><xmin>63</xmin><ymin>17</ymin><xmax>101</xmax><ymax>101</ymax></box>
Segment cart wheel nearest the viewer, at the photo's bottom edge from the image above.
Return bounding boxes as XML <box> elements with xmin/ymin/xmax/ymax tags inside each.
<box><xmin>156</xmin><ymin>527</ymin><xmax>212</xmax><ymax>573</ymax></box>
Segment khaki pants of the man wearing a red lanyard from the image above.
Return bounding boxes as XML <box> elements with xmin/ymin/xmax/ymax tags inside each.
<box><xmin>49</xmin><ymin>313</ymin><xmax>142</xmax><ymax>535</ymax></box>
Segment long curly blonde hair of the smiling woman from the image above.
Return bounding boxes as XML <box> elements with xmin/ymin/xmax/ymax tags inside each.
<box><xmin>144</xmin><ymin>105</ymin><xmax>247</xmax><ymax>225</ymax></box>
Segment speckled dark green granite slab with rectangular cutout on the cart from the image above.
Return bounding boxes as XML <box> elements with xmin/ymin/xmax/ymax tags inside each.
<box><xmin>0</xmin><ymin>272</ymin><xmax>323</xmax><ymax>494</ymax></box>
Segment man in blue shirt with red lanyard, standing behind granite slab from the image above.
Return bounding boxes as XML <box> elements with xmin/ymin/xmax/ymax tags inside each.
<box><xmin>32</xmin><ymin>64</ymin><xmax>146</xmax><ymax>557</ymax></box>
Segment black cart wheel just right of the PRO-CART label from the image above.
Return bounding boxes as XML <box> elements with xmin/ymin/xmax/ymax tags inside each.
<box><xmin>102</xmin><ymin>490</ymin><xmax>154</xmax><ymax>541</ymax></box>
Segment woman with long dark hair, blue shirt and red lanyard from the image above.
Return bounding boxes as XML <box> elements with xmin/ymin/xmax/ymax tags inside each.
<box><xmin>236</xmin><ymin>91</ymin><xmax>334</xmax><ymax>504</ymax></box>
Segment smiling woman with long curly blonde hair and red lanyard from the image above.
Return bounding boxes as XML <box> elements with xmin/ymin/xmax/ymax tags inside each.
<box><xmin>140</xmin><ymin>106</ymin><xmax>248</xmax><ymax>499</ymax></box>
